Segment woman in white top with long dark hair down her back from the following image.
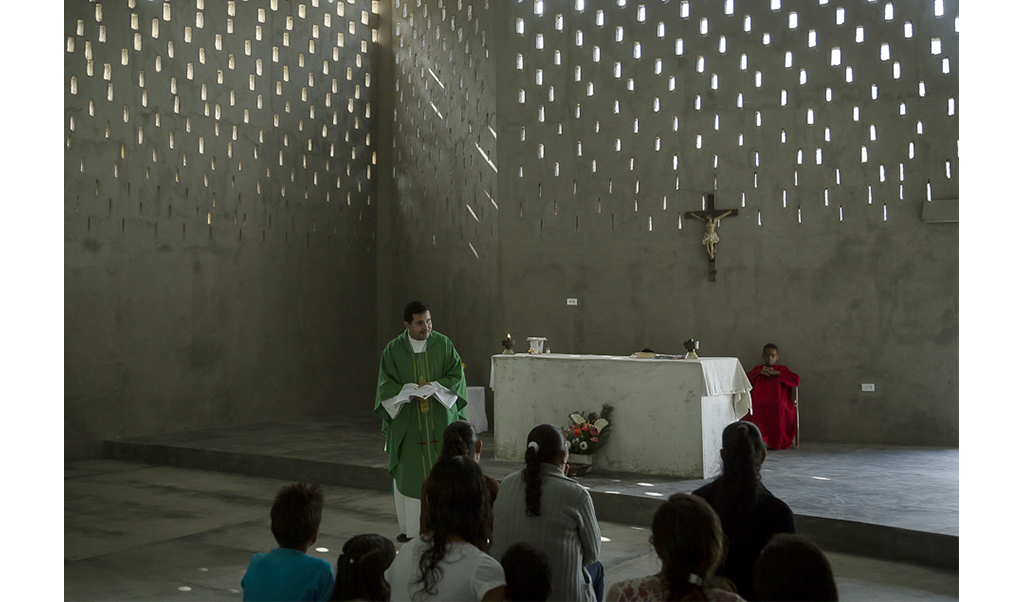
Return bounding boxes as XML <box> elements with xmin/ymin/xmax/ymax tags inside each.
<box><xmin>384</xmin><ymin>456</ymin><xmax>505</xmax><ymax>601</ymax></box>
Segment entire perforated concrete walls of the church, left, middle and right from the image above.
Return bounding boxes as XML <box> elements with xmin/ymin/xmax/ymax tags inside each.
<box><xmin>63</xmin><ymin>0</ymin><xmax>958</xmax><ymax>457</ymax></box>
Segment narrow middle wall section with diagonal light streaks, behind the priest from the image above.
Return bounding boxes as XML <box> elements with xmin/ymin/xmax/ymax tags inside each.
<box><xmin>378</xmin><ymin>0</ymin><xmax>505</xmax><ymax>386</ymax></box>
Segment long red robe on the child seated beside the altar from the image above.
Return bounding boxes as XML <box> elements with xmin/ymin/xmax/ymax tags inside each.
<box><xmin>742</xmin><ymin>364</ymin><xmax>800</xmax><ymax>449</ymax></box>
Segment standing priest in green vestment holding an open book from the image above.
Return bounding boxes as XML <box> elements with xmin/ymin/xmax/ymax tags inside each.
<box><xmin>374</xmin><ymin>301</ymin><xmax>467</xmax><ymax>542</ymax></box>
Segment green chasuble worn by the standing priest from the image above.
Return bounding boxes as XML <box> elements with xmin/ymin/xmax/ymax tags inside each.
<box><xmin>374</xmin><ymin>331</ymin><xmax>467</xmax><ymax>499</ymax></box>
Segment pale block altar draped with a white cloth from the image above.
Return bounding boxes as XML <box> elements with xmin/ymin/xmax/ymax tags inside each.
<box><xmin>490</xmin><ymin>353</ymin><xmax>751</xmax><ymax>479</ymax></box>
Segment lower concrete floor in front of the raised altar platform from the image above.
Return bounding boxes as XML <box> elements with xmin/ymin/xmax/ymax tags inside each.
<box><xmin>63</xmin><ymin>460</ymin><xmax>959</xmax><ymax>601</ymax></box>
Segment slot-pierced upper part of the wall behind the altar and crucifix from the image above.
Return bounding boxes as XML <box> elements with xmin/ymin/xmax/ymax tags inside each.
<box><xmin>499</xmin><ymin>0</ymin><xmax>958</xmax><ymax>238</ymax></box>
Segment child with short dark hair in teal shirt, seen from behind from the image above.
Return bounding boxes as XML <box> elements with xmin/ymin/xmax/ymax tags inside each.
<box><xmin>242</xmin><ymin>483</ymin><xmax>334</xmax><ymax>602</ymax></box>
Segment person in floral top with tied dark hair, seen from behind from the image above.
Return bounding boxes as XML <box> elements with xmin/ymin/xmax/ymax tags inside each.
<box><xmin>607</xmin><ymin>493</ymin><xmax>742</xmax><ymax>602</ymax></box>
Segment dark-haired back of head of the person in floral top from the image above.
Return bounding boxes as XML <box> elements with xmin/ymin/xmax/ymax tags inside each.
<box><xmin>651</xmin><ymin>493</ymin><xmax>725</xmax><ymax>600</ymax></box>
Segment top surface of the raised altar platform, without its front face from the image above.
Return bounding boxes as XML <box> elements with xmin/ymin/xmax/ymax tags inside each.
<box><xmin>103</xmin><ymin>413</ymin><xmax>959</xmax><ymax>535</ymax></box>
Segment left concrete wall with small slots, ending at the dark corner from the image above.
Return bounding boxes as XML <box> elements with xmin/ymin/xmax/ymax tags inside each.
<box><xmin>63</xmin><ymin>0</ymin><xmax>376</xmax><ymax>459</ymax></box>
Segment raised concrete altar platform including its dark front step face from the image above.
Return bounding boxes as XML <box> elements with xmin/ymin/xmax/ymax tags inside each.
<box><xmin>105</xmin><ymin>413</ymin><xmax>959</xmax><ymax>569</ymax></box>
